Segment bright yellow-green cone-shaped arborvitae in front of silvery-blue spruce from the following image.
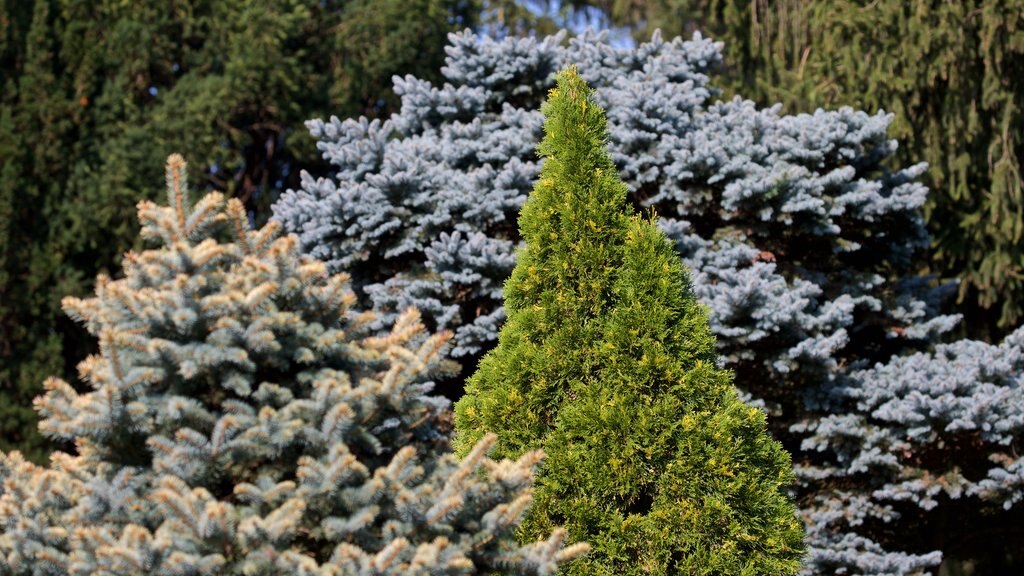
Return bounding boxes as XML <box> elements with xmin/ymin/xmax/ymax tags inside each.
<box><xmin>456</xmin><ymin>68</ymin><xmax>803</xmax><ymax>576</ymax></box>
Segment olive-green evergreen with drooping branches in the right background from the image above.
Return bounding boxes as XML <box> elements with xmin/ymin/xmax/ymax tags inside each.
<box><xmin>548</xmin><ymin>0</ymin><xmax>1024</xmax><ymax>340</ymax></box>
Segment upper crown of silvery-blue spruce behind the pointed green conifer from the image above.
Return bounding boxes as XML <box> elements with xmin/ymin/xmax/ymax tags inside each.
<box><xmin>274</xmin><ymin>28</ymin><xmax>950</xmax><ymax>373</ymax></box>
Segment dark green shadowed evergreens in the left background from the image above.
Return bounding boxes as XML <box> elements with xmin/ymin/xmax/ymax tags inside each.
<box><xmin>0</xmin><ymin>0</ymin><xmax>479</xmax><ymax>460</ymax></box>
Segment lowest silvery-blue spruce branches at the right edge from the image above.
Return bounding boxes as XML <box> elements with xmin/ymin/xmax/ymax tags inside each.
<box><xmin>797</xmin><ymin>328</ymin><xmax>1024</xmax><ymax>574</ymax></box>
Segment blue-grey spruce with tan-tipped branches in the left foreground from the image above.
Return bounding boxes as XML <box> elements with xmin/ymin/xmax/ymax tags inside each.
<box><xmin>0</xmin><ymin>156</ymin><xmax>586</xmax><ymax>576</ymax></box>
